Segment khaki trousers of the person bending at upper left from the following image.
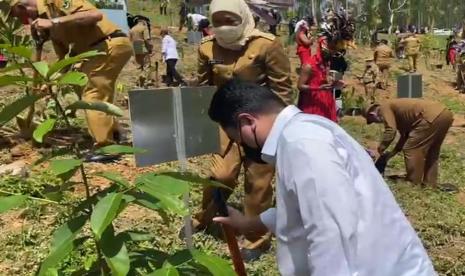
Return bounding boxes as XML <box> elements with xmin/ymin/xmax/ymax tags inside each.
<box><xmin>81</xmin><ymin>37</ymin><xmax>134</xmax><ymax>146</ymax></box>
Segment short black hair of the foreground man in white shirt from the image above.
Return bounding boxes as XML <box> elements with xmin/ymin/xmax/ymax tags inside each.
<box><xmin>208</xmin><ymin>78</ymin><xmax>286</xmax><ymax>128</ymax></box>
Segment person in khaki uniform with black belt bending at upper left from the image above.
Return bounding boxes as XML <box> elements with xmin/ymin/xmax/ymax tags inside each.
<box><xmin>10</xmin><ymin>0</ymin><xmax>133</xmax><ymax>161</ymax></box>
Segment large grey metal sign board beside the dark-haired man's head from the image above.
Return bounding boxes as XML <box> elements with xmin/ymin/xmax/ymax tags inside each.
<box><xmin>129</xmin><ymin>87</ymin><xmax>219</xmax><ymax>167</ymax></box>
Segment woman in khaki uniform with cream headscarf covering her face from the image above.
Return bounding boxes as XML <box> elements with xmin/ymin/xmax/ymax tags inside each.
<box><xmin>194</xmin><ymin>0</ymin><xmax>293</xmax><ymax>260</ymax></box>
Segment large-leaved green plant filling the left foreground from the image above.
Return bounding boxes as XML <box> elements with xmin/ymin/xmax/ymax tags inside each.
<box><xmin>0</xmin><ymin>15</ymin><xmax>234</xmax><ymax>276</ymax></box>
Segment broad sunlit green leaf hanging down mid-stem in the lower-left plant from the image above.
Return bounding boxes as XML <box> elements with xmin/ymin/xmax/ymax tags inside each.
<box><xmin>90</xmin><ymin>193</ymin><xmax>123</xmax><ymax>239</ymax></box>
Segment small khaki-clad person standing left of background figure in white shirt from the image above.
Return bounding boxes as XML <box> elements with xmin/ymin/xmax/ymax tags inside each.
<box><xmin>129</xmin><ymin>19</ymin><xmax>153</xmax><ymax>70</ymax></box>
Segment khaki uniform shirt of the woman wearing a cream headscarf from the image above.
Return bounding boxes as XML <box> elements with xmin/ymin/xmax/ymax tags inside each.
<box><xmin>198</xmin><ymin>33</ymin><xmax>294</xmax><ymax>104</ymax></box>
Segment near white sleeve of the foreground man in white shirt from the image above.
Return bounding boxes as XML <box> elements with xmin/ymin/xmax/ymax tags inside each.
<box><xmin>284</xmin><ymin>139</ymin><xmax>360</xmax><ymax>276</ymax></box>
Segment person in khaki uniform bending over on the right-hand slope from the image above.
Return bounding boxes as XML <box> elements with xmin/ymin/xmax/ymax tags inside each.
<box><xmin>365</xmin><ymin>99</ymin><xmax>454</xmax><ymax>187</ymax></box>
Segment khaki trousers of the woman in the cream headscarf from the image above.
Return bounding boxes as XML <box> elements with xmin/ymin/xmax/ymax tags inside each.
<box><xmin>194</xmin><ymin>130</ymin><xmax>274</xmax><ymax>249</ymax></box>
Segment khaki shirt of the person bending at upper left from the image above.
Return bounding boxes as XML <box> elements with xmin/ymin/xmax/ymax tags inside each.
<box><xmin>37</xmin><ymin>0</ymin><xmax>120</xmax><ymax>58</ymax></box>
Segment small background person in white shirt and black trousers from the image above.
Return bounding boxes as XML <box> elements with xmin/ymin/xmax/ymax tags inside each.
<box><xmin>160</xmin><ymin>29</ymin><xmax>186</xmax><ymax>86</ymax></box>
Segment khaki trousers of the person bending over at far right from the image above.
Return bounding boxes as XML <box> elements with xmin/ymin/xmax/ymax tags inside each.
<box><xmin>403</xmin><ymin>110</ymin><xmax>454</xmax><ymax>186</ymax></box>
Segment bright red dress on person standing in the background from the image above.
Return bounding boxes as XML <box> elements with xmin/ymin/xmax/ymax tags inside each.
<box><xmin>298</xmin><ymin>38</ymin><xmax>337</xmax><ymax>122</ymax></box>
